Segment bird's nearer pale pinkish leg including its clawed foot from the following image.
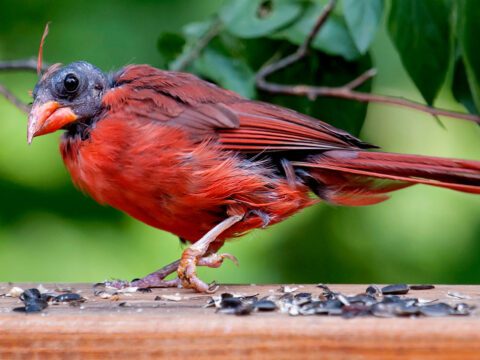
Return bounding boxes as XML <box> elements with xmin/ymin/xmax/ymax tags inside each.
<box><xmin>177</xmin><ymin>215</ymin><xmax>243</xmax><ymax>292</ymax></box>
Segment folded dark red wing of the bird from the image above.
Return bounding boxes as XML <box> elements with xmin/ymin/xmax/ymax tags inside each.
<box><xmin>104</xmin><ymin>65</ymin><xmax>372</xmax><ymax>152</ymax></box>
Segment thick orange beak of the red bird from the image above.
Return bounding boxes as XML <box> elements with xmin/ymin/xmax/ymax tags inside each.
<box><xmin>27</xmin><ymin>101</ymin><xmax>77</xmax><ymax>144</ymax></box>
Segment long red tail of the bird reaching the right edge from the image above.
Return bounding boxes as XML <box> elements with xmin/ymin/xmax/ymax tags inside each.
<box><xmin>292</xmin><ymin>150</ymin><xmax>480</xmax><ymax>206</ymax></box>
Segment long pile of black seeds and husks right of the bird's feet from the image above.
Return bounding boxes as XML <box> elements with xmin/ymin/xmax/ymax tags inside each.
<box><xmin>206</xmin><ymin>284</ymin><xmax>473</xmax><ymax>319</ymax></box>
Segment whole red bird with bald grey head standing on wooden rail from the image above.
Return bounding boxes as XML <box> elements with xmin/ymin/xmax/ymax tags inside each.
<box><xmin>28</xmin><ymin>62</ymin><xmax>480</xmax><ymax>292</ymax></box>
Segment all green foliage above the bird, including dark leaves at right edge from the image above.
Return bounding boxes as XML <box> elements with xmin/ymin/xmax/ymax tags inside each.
<box><xmin>158</xmin><ymin>0</ymin><xmax>480</xmax><ymax>134</ymax></box>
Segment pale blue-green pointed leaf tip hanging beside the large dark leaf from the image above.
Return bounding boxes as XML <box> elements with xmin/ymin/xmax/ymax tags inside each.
<box><xmin>343</xmin><ymin>0</ymin><xmax>383</xmax><ymax>54</ymax></box>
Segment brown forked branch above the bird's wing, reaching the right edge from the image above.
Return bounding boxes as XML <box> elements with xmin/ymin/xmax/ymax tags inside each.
<box><xmin>256</xmin><ymin>0</ymin><xmax>480</xmax><ymax>124</ymax></box>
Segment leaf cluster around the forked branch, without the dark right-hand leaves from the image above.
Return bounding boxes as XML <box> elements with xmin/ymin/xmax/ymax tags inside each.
<box><xmin>158</xmin><ymin>0</ymin><xmax>382</xmax><ymax>134</ymax></box>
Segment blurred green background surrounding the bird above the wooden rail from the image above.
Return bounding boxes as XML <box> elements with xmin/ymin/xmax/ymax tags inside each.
<box><xmin>0</xmin><ymin>0</ymin><xmax>480</xmax><ymax>283</ymax></box>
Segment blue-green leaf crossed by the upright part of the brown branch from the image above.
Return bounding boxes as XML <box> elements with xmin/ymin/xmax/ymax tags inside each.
<box><xmin>273</xmin><ymin>3</ymin><xmax>360</xmax><ymax>60</ymax></box>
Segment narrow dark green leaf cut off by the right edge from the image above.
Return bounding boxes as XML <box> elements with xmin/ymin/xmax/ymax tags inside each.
<box><xmin>459</xmin><ymin>0</ymin><xmax>480</xmax><ymax>109</ymax></box>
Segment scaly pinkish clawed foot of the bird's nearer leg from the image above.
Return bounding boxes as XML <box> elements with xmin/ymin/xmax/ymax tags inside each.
<box><xmin>177</xmin><ymin>248</ymin><xmax>238</xmax><ymax>293</ymax></box>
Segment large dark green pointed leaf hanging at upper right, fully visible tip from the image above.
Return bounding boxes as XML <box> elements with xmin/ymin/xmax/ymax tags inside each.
<box><xmin>388</xmin><ymin>0</ymin><xmax>451</xmax><ymax>105</ymax></box>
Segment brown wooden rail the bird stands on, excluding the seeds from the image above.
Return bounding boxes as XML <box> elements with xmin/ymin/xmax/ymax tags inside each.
<box><xmin>0</xmin><ymin>284</ymin><xmax>480</xmax><ymax>359</ymax></box>
